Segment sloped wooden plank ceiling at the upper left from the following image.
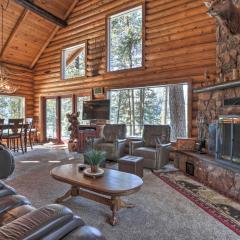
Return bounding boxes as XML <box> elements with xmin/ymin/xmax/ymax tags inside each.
<box><xmin>0</xmin><ymin>0</ymin><xmax>78</xmax><ymax>68</ymax></box>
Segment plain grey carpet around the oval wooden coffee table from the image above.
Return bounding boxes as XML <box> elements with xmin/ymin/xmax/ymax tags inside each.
<box><xmin>5</xmin><ymin>147</ymin><xmax>239</xmax><ymax>240</ymax></box>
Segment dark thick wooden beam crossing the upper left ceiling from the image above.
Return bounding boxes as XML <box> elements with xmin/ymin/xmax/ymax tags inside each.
<box><xmin>15</xmin><ymin>0</ymin><xmax>68</xmax><ymax>27</ymax></box>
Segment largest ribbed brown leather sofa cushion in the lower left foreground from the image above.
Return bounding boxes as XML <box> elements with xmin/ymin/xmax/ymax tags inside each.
<box><xmin>0</xmin><ymin>204</ymin><xmax>84</xmax><ymax>240</ymax></box>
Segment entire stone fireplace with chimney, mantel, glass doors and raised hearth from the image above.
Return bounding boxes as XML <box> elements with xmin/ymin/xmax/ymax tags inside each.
<box><xmin>175</xmin><ymin>0</ymin><xmax>240</xmax><ymax>201</ymax></box>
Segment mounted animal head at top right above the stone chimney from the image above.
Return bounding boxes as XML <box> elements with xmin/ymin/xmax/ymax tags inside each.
<box><xmin>204</xmin><ymin>0</ymin><xmax>240</xmax><ymax>35</ymax></box>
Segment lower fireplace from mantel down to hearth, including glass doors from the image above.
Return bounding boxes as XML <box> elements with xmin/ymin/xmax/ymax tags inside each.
<box><xmin>175</xmin><ymin>84</ymin><xmax>240</xmax><ymax>201</ymax></box>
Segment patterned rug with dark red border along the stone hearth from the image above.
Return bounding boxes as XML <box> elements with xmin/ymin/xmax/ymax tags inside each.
<box><xmin>155</xmin><ymin>172</ymin><xmax>240</xmax><ymax>235</ymax></box>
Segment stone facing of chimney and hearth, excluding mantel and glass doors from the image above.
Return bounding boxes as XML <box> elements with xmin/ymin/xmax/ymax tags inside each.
<box><xmin>174</xmin><ymin>0</ymin><xmax>240</xmax><ymax>201</ymax></box>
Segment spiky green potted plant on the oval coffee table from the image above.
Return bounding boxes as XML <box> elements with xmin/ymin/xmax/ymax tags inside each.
<box><xmin>85</xmin><ymin>149</ymin><xmax>106</xmax><ymax>173</ymax></box>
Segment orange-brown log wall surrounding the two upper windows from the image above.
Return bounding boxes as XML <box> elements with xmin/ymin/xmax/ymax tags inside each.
<box><xmin>34</xmin><ymin>0</ymin><xmax>216</xmax><ymax>136</ymax></box>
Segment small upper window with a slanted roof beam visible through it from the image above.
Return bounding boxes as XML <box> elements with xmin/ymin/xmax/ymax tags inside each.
<box><xmin>62</xmin><ymin>43</ymin><xmax>86</xmax><ymax>80</ymax></box>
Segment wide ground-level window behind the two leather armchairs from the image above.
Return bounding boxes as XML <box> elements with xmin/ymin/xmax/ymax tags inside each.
<box><xmin>109</xmin><ymin>84</ymin><xmax>188</xmax><ymax>140</ymax></box>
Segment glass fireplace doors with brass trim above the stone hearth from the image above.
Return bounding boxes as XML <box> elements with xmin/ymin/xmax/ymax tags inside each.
<box><xmin>217</xmin><ymin>116</ymin><xmax>240</xmax><ymax>164</ymax></box>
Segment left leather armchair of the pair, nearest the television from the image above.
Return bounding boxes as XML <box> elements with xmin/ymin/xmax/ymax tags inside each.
<box><xmin>93</xmin><ymin>124</ymin><xmax>126</xmax><ymax>161</ymax></box>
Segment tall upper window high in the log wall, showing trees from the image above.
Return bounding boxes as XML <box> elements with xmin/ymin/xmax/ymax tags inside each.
<box><xmin>108</xmin><ymin>6</ymin><xmax>143</xmax><ymax>71</ymax></box>
